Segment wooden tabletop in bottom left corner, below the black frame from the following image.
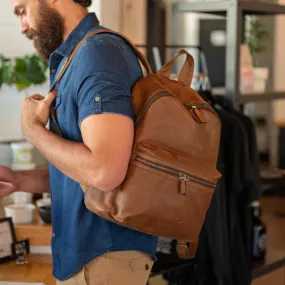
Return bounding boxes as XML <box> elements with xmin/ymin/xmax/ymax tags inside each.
<box><xmin>0</xmin><ymin>254</ymin><xmax>56</xmax><ymax>285</ymax></box>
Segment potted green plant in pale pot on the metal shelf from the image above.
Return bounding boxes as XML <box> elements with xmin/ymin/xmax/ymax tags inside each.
<box><xmin>245</xmin><ymin>16</ymin><xmax>269</xmax><ymax>92</ymax></box>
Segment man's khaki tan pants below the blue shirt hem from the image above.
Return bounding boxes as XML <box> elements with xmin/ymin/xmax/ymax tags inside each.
<box><xmin>57</xmin><ymin>251</ymin><xmax>153</xmax><ymax>285</ymax></box>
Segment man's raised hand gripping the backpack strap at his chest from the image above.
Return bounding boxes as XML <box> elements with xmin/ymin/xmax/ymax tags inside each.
<box><xmin>21</xmin><ymin>91</ymin><xmax>57</xmax><ymax>140</ymax></box>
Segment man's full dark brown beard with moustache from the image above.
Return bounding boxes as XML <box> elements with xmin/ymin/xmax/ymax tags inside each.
<box><xmin>26</xmin><ymin>0</ymin><xmax>64</xmax><ymax>60</ymax></box>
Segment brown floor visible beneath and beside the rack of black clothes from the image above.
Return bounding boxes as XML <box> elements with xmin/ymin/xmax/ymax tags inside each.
<box><xmin>150</xmin><ymin>197</ymin><xmax>285</xmax><ymax>285</ymax></box>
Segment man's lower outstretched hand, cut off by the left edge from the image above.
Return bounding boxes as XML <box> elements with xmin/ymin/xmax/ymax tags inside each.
<box><xmin>0</xmin><ymin>165</ymin><xmax>18</xmax><ymax>197</ymax></box>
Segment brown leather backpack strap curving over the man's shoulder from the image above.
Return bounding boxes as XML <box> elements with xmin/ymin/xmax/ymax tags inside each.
<box><xmin>50</xmin><ymin>29</ymin><xmax>153</xmax><ymax>92</ymax></box>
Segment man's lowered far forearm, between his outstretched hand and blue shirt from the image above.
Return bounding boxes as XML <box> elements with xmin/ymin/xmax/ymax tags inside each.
<box><xmin>17</xmin><ymin>168</ymin><xmax>50</xmax><ymax>194</ymax></box>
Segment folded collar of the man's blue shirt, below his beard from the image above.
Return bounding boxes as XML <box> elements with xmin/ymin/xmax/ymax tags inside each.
<box><xmin>52</xmin><ymin>13</ymin><xmax>99</xmax><ymax>57</ymax></box>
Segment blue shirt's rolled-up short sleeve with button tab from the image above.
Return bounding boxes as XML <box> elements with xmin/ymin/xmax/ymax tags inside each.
<box><xmin>75</xmin><ymin>39</ymin><xmax>134</xmax><ymax>126</ymax></box>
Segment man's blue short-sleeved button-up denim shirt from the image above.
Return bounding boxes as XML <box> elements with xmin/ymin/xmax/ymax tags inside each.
<box><xmin>49</xmin><ymin>13</ymin><xmax>157</xmax><ymax>281</ymax></box>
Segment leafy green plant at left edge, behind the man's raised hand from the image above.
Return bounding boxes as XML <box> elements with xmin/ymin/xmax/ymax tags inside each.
<box><xmin>0</xmin><ymin>55</ymin><xmax>48</xmax><ymax>95</ymax></box>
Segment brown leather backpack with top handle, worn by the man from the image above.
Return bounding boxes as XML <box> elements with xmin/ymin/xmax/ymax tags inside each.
<box><xmin>51</xmin><ymin>30</ymin><xmax>221</xmax><ymax>259</ymax></box>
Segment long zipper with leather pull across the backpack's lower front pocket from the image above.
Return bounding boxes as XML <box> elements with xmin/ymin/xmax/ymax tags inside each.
<box><xmin>134</xmin><ymin>155</ymin><xmax>216</xmax><ymax>195</ymax></box>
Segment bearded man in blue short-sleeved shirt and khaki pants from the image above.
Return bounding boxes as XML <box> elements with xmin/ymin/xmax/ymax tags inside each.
<box><xmin>0</xmin><ymin>0</ymin><xmax>157</xmax><ymax>285</ymax></box>
